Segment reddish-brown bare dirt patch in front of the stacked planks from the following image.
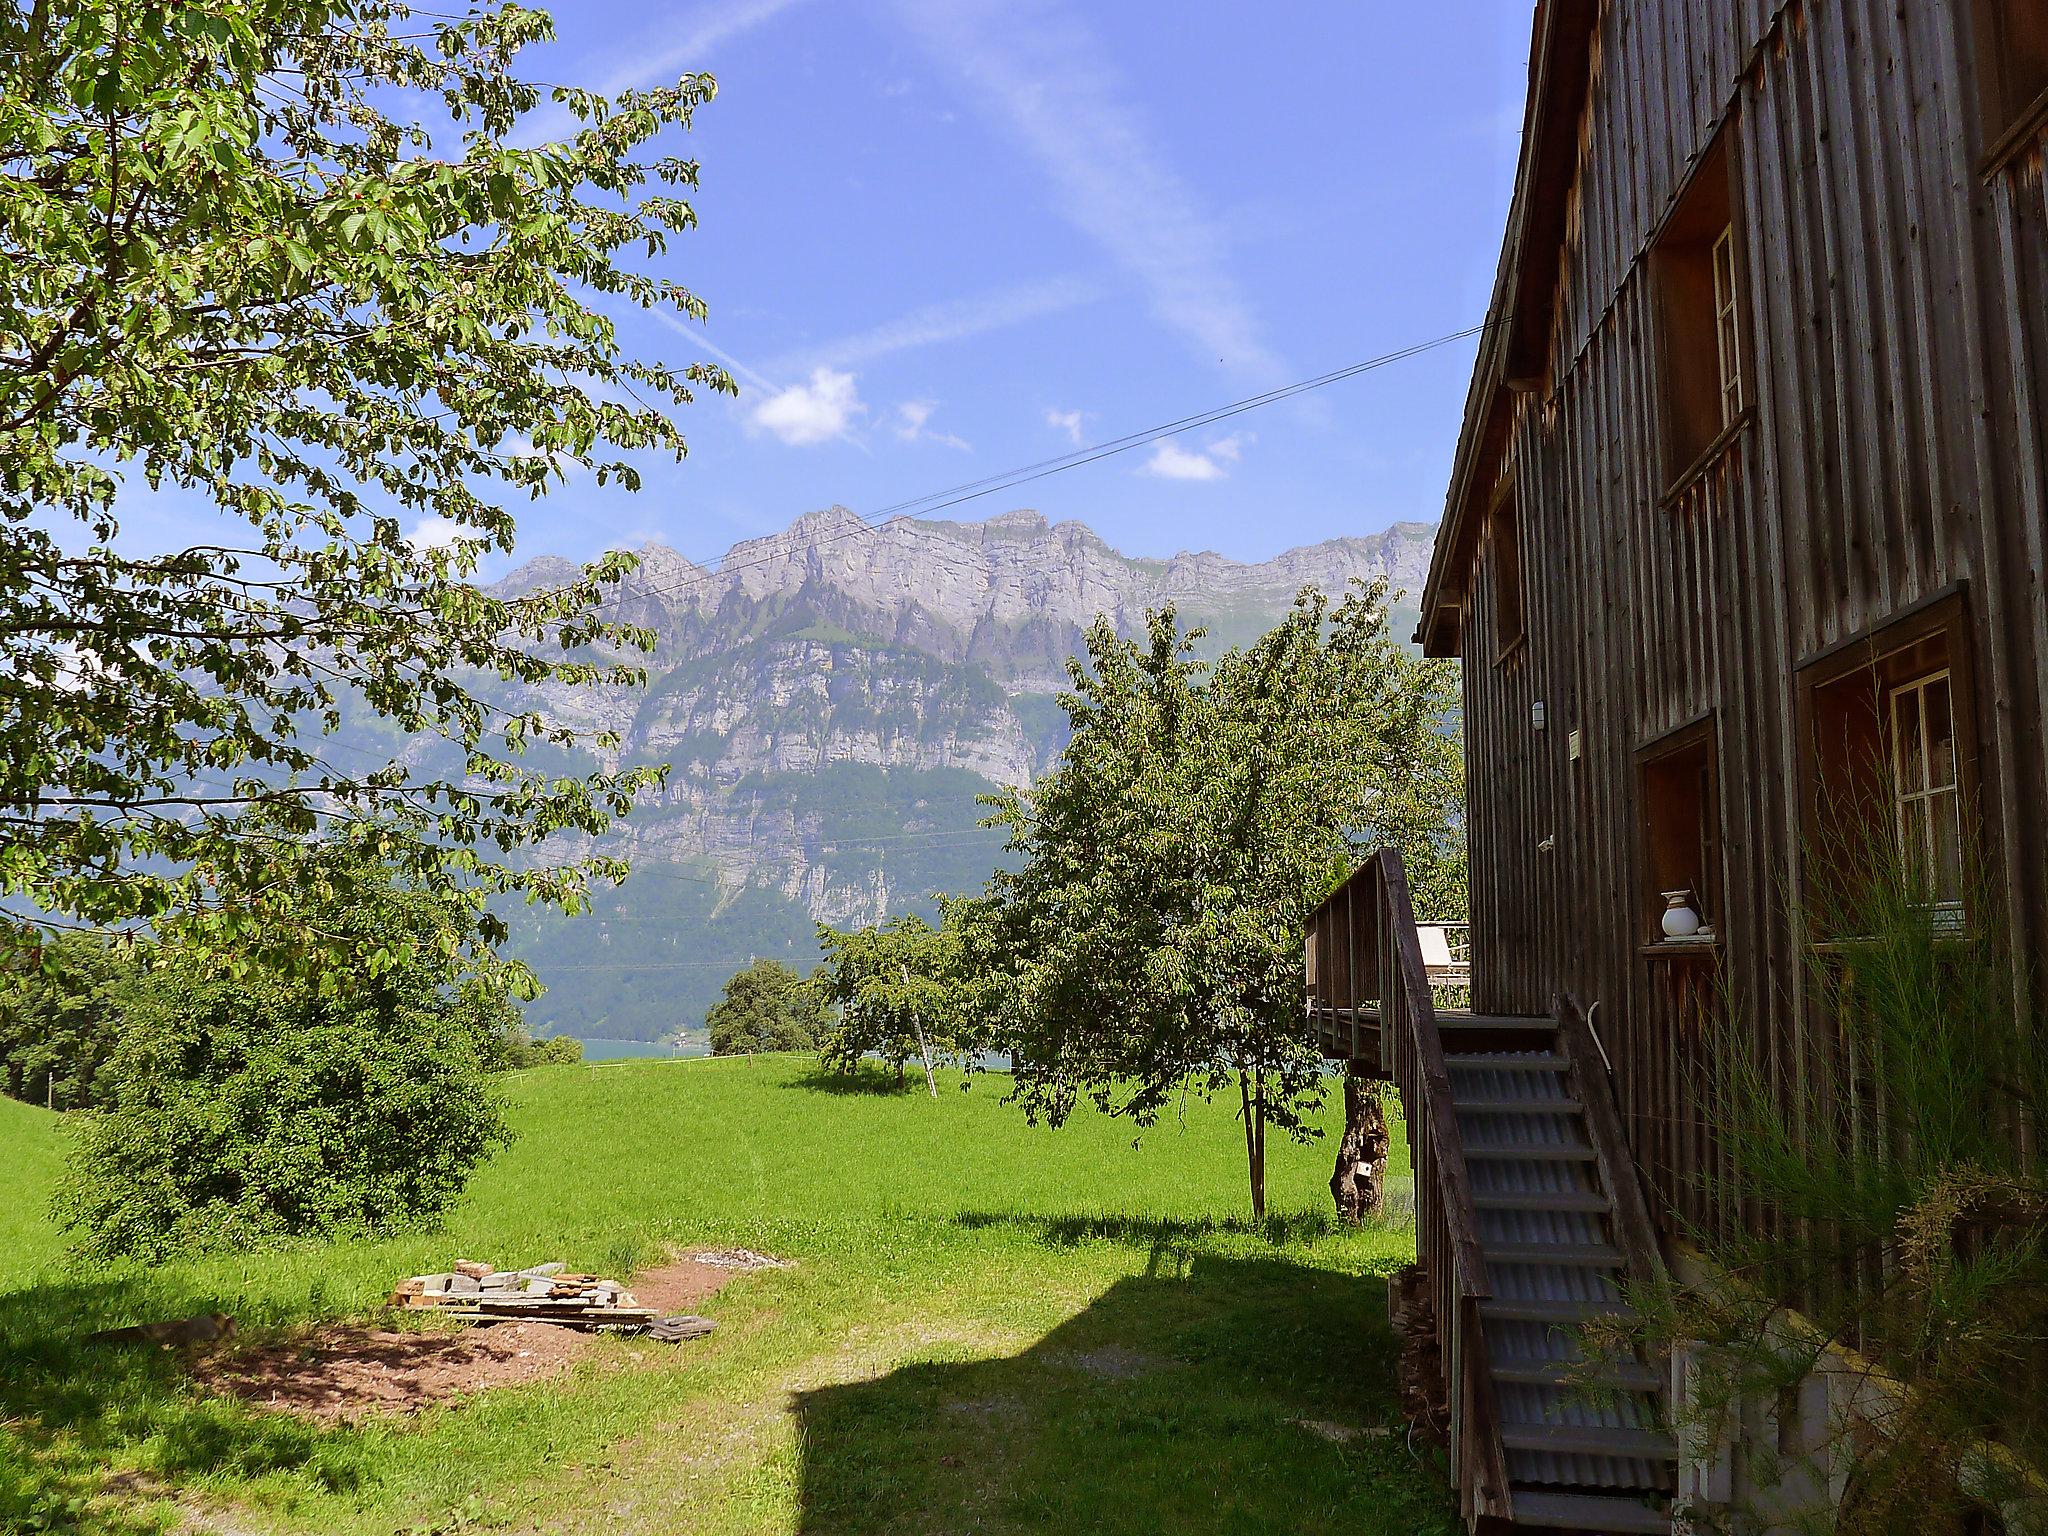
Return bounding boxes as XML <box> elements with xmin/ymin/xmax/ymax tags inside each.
<box><xmin>193</xmin><ymin>1323</ymin><xmax>594</xmax><ymax>1423</ymax></box>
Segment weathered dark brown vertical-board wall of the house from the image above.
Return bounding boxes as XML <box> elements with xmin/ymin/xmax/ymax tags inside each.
<box><xmin>1446</xmin><ymin>0</ymin><xmax>2048</xmax><ymax>1245</ymax></box>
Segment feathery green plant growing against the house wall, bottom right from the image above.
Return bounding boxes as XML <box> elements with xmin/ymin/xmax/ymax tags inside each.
<box><xmin>1636</xmin><ymin>798</ymin><xmax>2048</xmax><ymax>1536</ymax></box>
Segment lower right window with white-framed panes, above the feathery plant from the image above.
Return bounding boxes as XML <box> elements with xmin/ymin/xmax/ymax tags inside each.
<box><xmin>1802</xmin><ymin>598</ymin><xmax>1972</xmax><ymax>924</ymax></box>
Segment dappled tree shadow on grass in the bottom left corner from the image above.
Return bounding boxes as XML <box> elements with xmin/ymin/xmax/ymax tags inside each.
<box><xmin>0</xmin><ymin>1272</ymin><xmax>362</xmax><ymax>1536</ymax></box>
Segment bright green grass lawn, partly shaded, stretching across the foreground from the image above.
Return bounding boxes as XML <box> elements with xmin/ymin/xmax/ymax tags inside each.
<box><xmin>0</xmin><ymin>1057</ymin><xmax>1456</xmax><ymax>1536</ymax></box>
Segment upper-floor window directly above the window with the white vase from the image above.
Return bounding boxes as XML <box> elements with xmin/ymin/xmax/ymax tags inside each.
<box><xmin>1651</xmin><ymin>141</ymin><xmax>1749</xmax><ymax>485</ymax></box>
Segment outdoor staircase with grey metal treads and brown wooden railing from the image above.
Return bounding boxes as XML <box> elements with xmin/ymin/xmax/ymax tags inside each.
<box><xmin>1307</xmin><ymin>850</ymin><xmax>1677</xmax><ymax>1536</ymax></box>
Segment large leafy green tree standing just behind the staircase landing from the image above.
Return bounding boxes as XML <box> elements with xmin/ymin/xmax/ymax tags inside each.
<box><xmin>971</xmin><ymin>586</ymin><xmax>1462</xmax><ymax>1219</ymax></box>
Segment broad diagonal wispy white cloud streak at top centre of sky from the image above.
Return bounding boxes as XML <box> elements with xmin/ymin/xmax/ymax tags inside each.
<box><xmin>897</xmin><ymin>0</ymin><xmax>1286</xmax><ymax>379</ymax></box>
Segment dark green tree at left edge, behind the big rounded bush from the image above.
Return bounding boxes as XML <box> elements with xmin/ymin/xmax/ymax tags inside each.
<box><xmin>0</xmin><ymin>934</ymin><xmax>150</xmax><ymax>1110</ymax></box>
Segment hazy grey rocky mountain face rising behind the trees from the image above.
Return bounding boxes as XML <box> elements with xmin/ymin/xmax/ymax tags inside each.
<box><xmin>487</xmin><ymin>508</ymin><xmax>1434</xmax><ymax>1038</ymax></box>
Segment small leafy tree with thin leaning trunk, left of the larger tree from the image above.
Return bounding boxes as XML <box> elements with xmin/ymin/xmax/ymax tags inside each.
<box><xmin>817</xmin><ymin>903</ymin><xmax>979</xmax><ymax>1098</ymax></box>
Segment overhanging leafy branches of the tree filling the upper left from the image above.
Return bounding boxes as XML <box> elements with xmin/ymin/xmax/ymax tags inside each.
<box><xmin>0</xmin><ymin>0</ymin><xmax>733</xmax><ymax>967</ymax></box>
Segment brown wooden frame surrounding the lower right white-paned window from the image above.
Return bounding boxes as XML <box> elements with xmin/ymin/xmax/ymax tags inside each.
<box><xmin>1794</xmin><ymin>582</ymin><xmax>1980</xmax><ymax>928</ymax></box>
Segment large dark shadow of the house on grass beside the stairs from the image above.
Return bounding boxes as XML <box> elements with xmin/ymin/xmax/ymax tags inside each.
<box><xmin>797</xmin><ymin>1243</ymin><xmax>1460</xmax><ymax>1536</ymax></box>
